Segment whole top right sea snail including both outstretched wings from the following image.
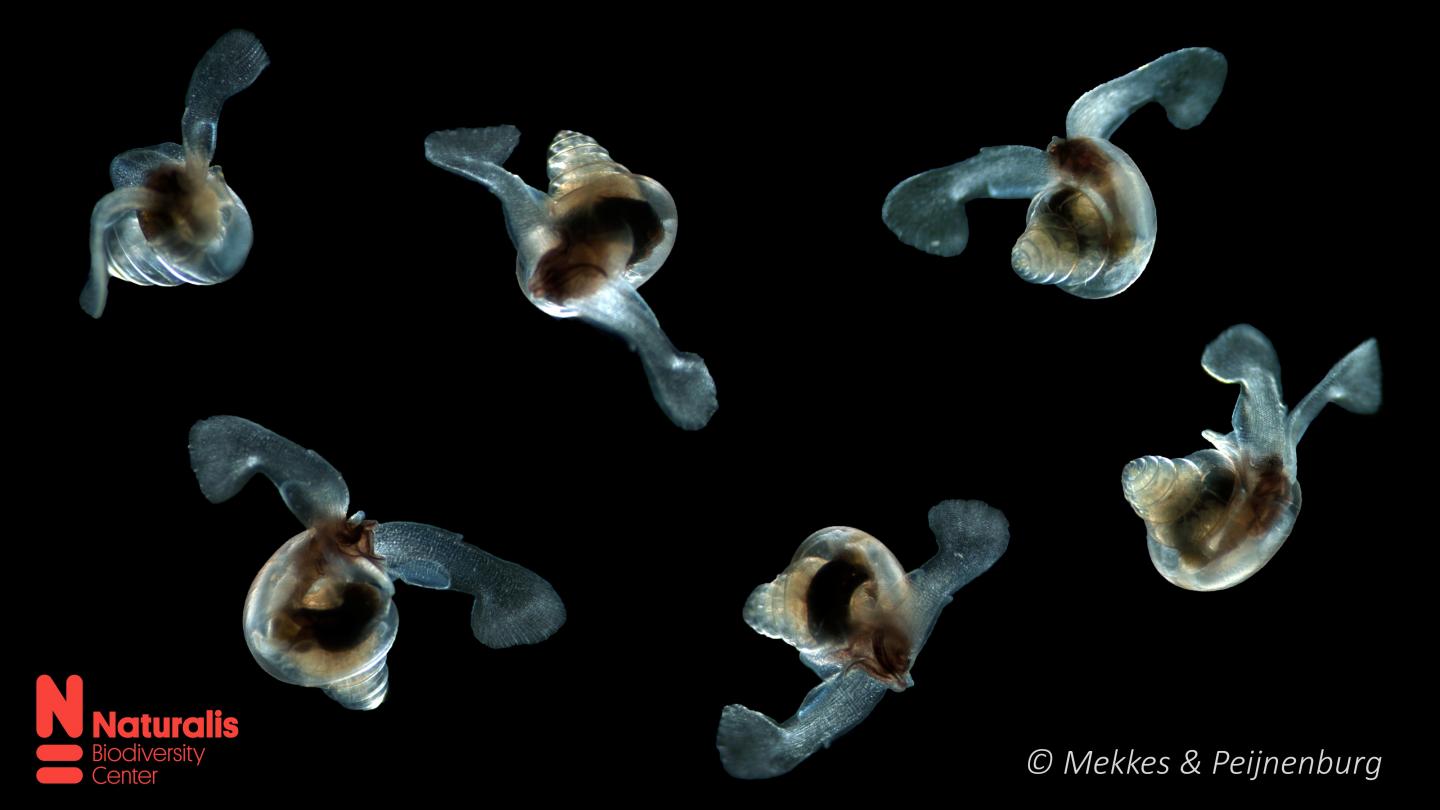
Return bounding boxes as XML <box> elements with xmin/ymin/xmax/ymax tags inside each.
<box><xmin>881</xmin><ymin>48</ymin><xmax>1227</xmax><ymax>298</ymax></box>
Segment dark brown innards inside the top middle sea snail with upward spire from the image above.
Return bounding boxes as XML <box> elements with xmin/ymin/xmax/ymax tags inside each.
<box><xmin>530</xmin><ymin>192</ymin><xmax>664</xmax><ymax>301</ymax></box>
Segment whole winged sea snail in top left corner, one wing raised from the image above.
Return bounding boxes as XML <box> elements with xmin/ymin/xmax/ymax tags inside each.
<box><xmin>81</xmin><ymin>30</ymin><xmax>269</xmax><ymax>317</ymax></box>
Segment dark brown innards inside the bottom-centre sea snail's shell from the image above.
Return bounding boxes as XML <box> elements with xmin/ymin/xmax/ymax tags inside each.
<box><xmin>805</xmin><ymin>553</ymin><xmax>910</xmax><ymax>682</ymax></box>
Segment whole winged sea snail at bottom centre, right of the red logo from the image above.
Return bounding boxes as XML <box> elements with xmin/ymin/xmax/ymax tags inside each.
<box><xmin>716</xmin><ymin>500</ymin><xmax>1009</xmax><ymax>778</ymax></box>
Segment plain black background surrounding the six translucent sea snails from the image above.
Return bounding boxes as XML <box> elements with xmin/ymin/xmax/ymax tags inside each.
<box><xmin>19</xmin><ymin>7</ymin><xmax>1416</xmax><ymax>801</ymax></box>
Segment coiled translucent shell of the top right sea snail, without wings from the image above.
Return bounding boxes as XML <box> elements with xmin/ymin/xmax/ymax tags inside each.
<box><xmin>1011</xmin><ymin>137</ymin><xmax>1155</xmax><ymax>298</ymax></box>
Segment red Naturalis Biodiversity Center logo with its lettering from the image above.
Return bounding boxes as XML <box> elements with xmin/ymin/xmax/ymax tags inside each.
<box><xmin>35</xmin><ymin>675</ymin><xmax>240</xmax><ymax>784</ymax></box>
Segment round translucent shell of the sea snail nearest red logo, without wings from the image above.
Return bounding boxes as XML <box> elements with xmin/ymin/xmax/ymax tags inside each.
<box><xmin>245</xmin><ymin>529</ymin><xmax>399</xmax><ymax>709</ymax></box>
